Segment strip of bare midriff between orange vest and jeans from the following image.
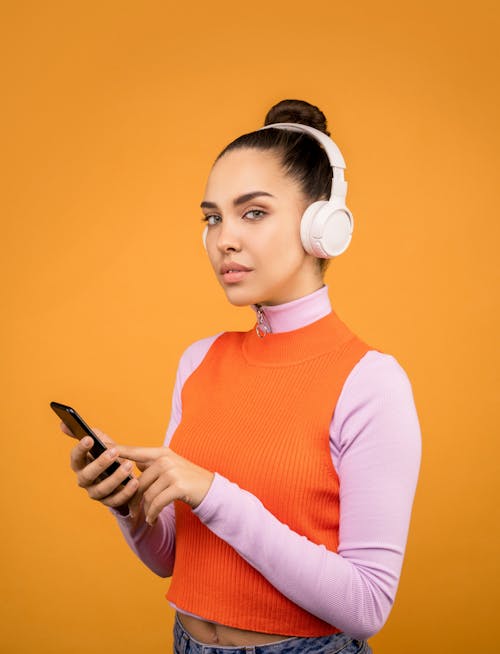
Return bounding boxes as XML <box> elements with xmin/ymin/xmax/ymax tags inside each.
<box><xmin>177</xmin><ymin>612</ymin><xmax>291</xmax><ymax>647</ymax></box>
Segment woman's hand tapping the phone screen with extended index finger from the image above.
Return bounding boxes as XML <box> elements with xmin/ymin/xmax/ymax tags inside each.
<box><xmin>117</xmin><ymin>445</ymin><xmax>214</xmax><ymax>525</ymax></box>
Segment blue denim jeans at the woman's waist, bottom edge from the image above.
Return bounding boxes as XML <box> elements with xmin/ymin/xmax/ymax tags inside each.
<box><xmin>174</xmin><ymin>616</ymin><xmax>372</xmax><ymax>654</ymax></box>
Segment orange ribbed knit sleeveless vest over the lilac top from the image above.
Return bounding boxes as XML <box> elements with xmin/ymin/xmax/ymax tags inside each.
<box><xmin>167</xmin><ymin>311</ymin><xmax>372</xmax><ymax>636</ymax></box>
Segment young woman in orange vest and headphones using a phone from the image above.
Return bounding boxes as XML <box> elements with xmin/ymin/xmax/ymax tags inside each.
<box><xmin>64</xmin><ymin>100</ymin><xmax>421</xmax><ymax>654</ymax></box>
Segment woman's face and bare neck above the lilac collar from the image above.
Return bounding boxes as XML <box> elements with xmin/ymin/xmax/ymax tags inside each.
<box><xmin>201</xmin><ymin>148</ymin><xmax>323</xmax><ymax>306</ymax></box>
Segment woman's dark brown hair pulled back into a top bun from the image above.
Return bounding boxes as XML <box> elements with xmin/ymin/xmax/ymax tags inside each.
<box><xmin>216</xmin><ymin>100</ymin><xmax>332</xmax><ymax>275</ymax></box>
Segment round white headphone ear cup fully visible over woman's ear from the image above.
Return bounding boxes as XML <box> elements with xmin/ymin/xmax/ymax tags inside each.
<box><xmin>300</xmin><ymin>200</ymin><xmax>354</xmax><ymax>259</ymax></box>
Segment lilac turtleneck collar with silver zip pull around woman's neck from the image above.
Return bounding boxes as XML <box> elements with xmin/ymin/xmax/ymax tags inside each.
<box><xmin>250</xmin><ymin>284</ymin><xmax>332</xmax><ymax>336</ymax></box>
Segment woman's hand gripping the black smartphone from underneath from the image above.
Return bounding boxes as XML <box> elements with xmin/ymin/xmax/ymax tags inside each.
<box><xmin>61</xmin><ymin>423</ymin><xmax>139</xmax><ymax>515</ymax></box>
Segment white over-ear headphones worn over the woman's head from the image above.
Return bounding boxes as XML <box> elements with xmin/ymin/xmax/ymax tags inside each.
<box><xmin>202</xmin><ymin>123</ymin><xmax>354</xmax><ymax>259</ymax></box>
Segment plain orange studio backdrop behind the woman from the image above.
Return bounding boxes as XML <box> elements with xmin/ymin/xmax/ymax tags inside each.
<box><xmin>0</xmin><ymin>0</ymin><xmax>500</xmax><ymax>654</ymax></box>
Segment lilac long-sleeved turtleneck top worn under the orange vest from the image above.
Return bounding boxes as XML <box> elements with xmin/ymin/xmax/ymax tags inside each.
<box><xmin>113</xmin><ymin>285</ymin><xmax>421</xmax><ymax>639</ymax></box>
